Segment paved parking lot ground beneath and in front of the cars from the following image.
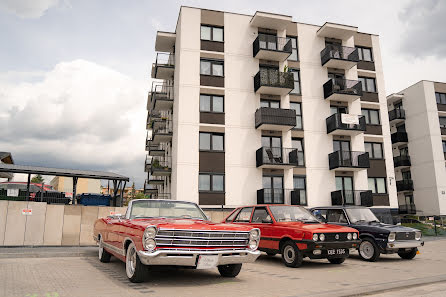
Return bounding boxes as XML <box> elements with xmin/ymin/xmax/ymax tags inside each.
<box><xmin>0</xmin><ymin>239</ymin><xmax>446</xmax><ymax>297</ymax></box>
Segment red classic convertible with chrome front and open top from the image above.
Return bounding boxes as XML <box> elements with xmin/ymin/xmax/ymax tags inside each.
<box><xmin>94</xmin><ymin>199</ymin><xmax>260</xmax><ymax>282</ymax></box>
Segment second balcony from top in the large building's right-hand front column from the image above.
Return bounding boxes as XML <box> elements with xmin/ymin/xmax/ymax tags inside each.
<box><xmin>324</xmin><ymin>78</ymin><xmax>362</xmax><ymax>102</ymax></box>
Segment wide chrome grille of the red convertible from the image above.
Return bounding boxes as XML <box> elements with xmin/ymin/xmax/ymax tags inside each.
<box><xmin>155</xmin><ymin>229</ymin><xmax>249</xmax><ymax>247</ymax></box>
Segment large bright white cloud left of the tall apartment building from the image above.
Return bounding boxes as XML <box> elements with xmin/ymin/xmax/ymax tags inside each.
<box><xmin>0</xmin><ymin>60</ymin><xmax>147</xmax><ymax>185</ymax></box>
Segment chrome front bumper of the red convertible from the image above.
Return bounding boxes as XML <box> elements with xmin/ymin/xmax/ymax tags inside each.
<box><xmin>138</xmin><ymin>250</ymin><xmax>260</xmax><ymax>266</ymax></box>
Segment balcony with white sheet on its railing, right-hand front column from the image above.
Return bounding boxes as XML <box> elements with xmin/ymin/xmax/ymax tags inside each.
<box><xmin>325</xmin><ymin>113</ymin><xmax>366</xmax><ymax>136</ymax></box>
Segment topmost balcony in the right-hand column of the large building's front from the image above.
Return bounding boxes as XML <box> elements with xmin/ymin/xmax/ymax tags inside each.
<box><xmin>321</xmin><ymin>44</ymin><xmax>359</xmax><ymax>70</ymax></box>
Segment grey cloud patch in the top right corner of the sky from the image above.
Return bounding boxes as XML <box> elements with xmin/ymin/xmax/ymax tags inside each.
<box><xmin>399</xmin><ymin>0</ymin><xmax>446</xmax><ymax>58</ymax></box>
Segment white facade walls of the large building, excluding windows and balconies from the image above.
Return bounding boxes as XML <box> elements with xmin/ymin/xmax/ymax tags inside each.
<box><xmin>148</xmin><ymin>7</ymin><xmax>398</xmax><ymax>215</ymax></box>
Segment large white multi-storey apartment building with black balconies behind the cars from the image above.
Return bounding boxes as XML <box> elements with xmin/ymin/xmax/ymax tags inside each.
<box><xmin>145</xmin><ymin>6</ymin><xmax>398</xmax><ymax>217</ymax></box>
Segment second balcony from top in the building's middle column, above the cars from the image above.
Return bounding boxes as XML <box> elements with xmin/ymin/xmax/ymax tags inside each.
<box><xmin>254</xmin><ymin>69</ymin><xmax>294</xmax><ymax>96</ymax></box>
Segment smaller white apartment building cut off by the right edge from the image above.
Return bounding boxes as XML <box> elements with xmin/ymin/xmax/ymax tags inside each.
<box><xmin>387</xmin><ymin>81</ymin><xmax>446</xmax><ymax>216</ymax></box>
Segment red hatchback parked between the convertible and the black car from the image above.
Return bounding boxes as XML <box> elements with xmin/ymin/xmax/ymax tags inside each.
<box><xmin>224</xmin><ymin>204</ymin><xmax>360</xmax><ymax>267</ymax></box>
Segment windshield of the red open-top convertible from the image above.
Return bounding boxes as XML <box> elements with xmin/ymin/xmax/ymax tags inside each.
<box><xmin>129</xmin><ymin>200</ymin><xmax>207</xmax><ymax>220</ymax></box>
